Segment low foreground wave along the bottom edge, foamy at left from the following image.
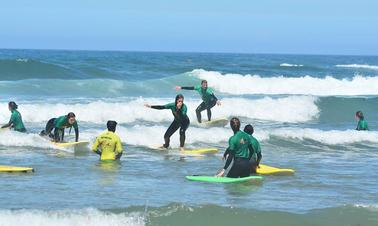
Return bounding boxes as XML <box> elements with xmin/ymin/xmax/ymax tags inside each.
<box><xmin>0</xmin><ymin>204</ymin><xmax>378</xmax><ymax>226</ymax></box>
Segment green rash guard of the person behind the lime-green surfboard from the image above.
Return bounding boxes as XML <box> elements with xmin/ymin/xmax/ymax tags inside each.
<box><xmin>228</xmin><ymin>131</ymin><xmax>253</xmax><ymax>158</ymax></box>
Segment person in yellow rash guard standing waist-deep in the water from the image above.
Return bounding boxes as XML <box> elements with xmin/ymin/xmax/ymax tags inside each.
<box><xmin>92</xmin><ymin>121</ymin><xmax>123</xmax><ymax>160</ymax></box>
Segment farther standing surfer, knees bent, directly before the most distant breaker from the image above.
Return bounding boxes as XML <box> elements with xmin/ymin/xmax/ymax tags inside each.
<box><xmin>176</xmin><ymin>80</ymin><xmax>221</xmax><ymax>123</ymax></box>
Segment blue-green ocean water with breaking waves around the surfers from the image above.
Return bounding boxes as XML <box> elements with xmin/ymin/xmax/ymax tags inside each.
<box><xmin>0</xmin><ymin>50</ymin><xmax>378</xmax><ymax>226</ymax></box>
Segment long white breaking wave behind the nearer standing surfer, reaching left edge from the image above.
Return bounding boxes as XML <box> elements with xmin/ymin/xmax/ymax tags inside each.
<box><xmin>0</xmin><ymin>96</ymin><xmax>319</xmax><ymax>123</ymax></box>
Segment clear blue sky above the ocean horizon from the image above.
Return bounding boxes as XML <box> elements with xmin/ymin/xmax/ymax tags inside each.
<box><xmin>0</xmin><ymin>0</ymin><xmax>378</xmax><ymax>55</ymax></box>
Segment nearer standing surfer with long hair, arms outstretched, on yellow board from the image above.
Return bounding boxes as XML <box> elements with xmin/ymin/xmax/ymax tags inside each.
<box><xmin>144</xmin><ymin>94</ymin><xmax>190</xmax><ymax>151</ymax></box>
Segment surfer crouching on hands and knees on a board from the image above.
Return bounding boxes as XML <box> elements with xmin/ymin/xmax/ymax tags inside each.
<box><xmin>40</xmin><ymin>112</ymin><xmax>79</xmax><ymax>142</ymax></box>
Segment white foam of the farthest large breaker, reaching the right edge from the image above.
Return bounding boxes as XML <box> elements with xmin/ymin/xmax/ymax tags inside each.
<box><xmin>189</xmin><ymin>69</ymin><xmax>378</xmax><ymax>96</ymax></box>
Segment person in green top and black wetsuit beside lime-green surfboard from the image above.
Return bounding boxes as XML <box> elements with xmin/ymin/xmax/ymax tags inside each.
<box><xmin>217</xmin><ymin>117</ymin><xmax>254</xmax><ymax>178</ymax></box>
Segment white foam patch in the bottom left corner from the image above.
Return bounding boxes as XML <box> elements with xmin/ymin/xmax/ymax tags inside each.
<box><xmin>0</xmin><ymin>209</ymin><xmax>145</xmax><ymax>226</ymax></box>
